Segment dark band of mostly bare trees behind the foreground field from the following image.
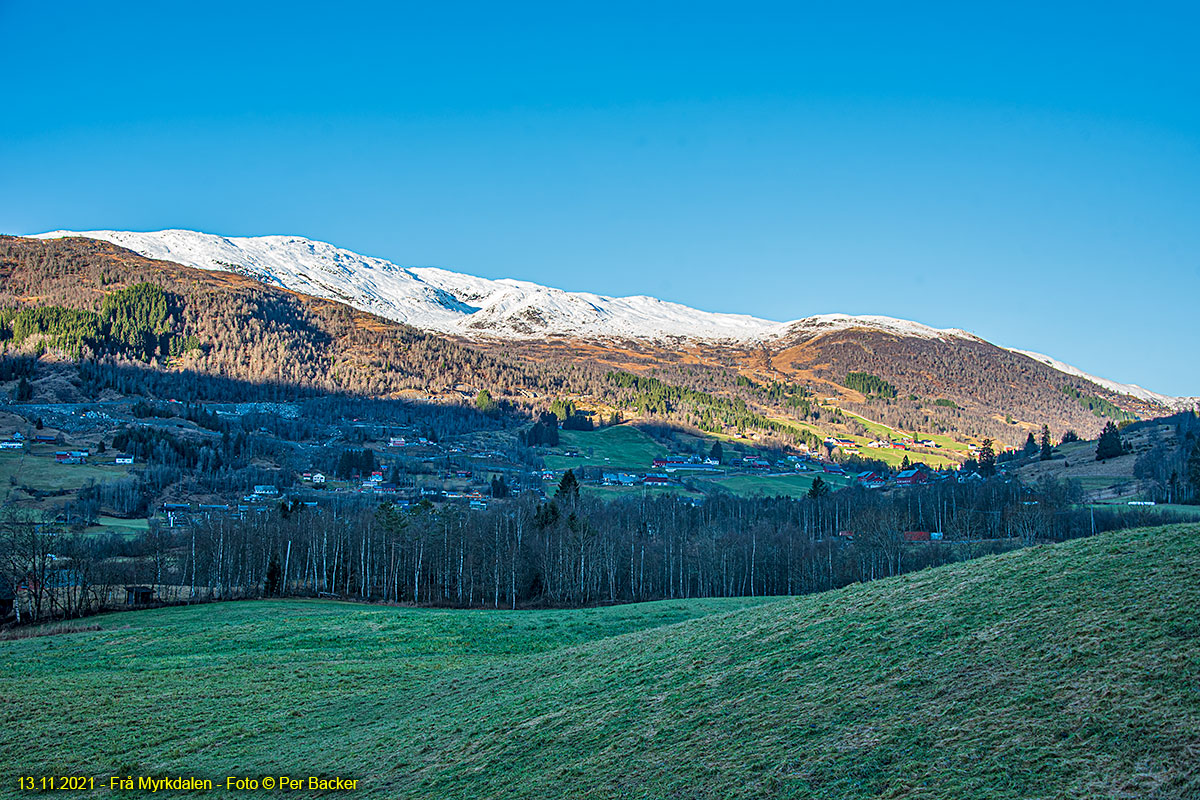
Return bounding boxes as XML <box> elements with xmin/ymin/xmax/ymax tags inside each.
<box><xmin>0</xmin><ymin>473</ymin><xmax>1195</xmax><ymax>619</ymax></box>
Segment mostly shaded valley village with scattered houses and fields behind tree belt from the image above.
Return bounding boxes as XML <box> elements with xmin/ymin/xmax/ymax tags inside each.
<box><xmin>0</xmin><ymin>388</ymin><xmax>1180</xmax><ymax>554</ymax></box>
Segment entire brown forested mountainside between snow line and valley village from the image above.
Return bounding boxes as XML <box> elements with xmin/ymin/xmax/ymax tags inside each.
<box><xmin>0</xmin><ymin>237</ymin><xmax>1163</xmax><ymax>446</ymax></box>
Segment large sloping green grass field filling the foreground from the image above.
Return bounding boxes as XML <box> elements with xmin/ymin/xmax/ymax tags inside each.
<box><xmin>0</xmin><ymin>525</ymin><xmax>1200</xmax><ymax>800</ymax></box>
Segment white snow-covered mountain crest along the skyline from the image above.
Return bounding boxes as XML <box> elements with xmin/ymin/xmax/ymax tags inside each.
<box><xmin>25</xmin><ymin>230</ymin><xmax>1200</xmax><ymax>409</ymax></box>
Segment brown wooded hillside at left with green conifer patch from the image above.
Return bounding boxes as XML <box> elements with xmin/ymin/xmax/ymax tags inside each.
<box><xmin>0</xmin><ymin>237</ymin><xmax>546</xmax><ymax>397</ymax></box>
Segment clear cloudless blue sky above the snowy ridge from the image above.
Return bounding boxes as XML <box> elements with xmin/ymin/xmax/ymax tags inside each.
<box><xmin>0</xmin><ymin>0</ymin><xmax>1200</xmax><ymax>395</ymax></box>
